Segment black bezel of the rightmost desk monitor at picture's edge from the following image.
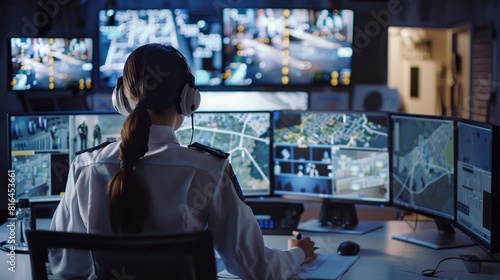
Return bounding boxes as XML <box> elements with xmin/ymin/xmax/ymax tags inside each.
<box><xmin>454</xmin><ymin>118</ymin><xmax>500</xmax><ymax>254</ymax></box>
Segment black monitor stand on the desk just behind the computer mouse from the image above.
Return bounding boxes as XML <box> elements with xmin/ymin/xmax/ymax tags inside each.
<box><xmin>297</xmin><ymin>199</ymin><xmax>384</xmax><ymax>234</ymax></box>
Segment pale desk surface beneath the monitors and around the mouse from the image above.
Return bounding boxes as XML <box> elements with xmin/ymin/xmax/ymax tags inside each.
<box><xmin>0</xmin><ymin>219</ymin><xmax>500</xmax><ymax>280</ymax></box>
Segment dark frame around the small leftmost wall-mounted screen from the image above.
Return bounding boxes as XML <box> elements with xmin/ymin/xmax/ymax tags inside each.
<box><xmin>6</xmin><ymin>36</ymin><xmax>96</xmax><ymax>94</ymax></box>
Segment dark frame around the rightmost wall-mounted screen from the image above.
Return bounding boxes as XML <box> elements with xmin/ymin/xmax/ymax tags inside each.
<box><xmin>219</xmin><ymin>5</ymin><xmax>356</xmax><ymax>88</ymax></box>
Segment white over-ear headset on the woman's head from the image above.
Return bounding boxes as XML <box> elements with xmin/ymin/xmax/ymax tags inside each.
<box><xmin>111</xmin><ymin>46</ymin><xmax>201</xmax><ymax>116</ymax></box>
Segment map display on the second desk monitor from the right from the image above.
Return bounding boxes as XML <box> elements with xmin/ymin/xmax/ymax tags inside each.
<box><xmin>391</xmin><ymin>115</ymin><xmax>454</xmax><ymax>219</ymax></box>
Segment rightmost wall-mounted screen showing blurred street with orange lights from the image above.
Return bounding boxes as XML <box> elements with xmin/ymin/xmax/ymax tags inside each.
<box><xmin>222</xmin><ymin>8</ymin><xmax>354</xmax><ymax>86</ymax></box>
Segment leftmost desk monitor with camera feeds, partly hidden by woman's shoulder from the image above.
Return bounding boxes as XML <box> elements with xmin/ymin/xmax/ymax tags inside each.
<box><xmin>8</xmin><ymin>112</ymin><xmax>125</xmax><ymax>203</ymax></box>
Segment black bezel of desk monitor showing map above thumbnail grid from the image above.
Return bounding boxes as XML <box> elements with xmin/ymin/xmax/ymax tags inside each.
<box><xmin>271</xmin><ymin>110</ymin><xmax>392</xmax><ymax>207</ymax></box>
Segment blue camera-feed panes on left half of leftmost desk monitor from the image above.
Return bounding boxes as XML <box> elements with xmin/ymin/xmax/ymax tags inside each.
<box><xmin>9</xmin><ymin>116</ymin><xmax>69</xmax><ymax>198</ymax></box>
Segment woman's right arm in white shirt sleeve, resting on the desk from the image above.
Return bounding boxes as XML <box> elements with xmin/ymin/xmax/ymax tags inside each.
<box><xmin>208</xmin><ymin>164</ymin><xmax>305</xmax><ymax>280</ymax></box>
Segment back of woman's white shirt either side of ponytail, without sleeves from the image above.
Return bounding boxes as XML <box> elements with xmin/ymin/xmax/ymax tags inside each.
<box><xmin>68</xmin><ymin>125</ymin><xmax>227</xmax><ymax>233</ymax></box>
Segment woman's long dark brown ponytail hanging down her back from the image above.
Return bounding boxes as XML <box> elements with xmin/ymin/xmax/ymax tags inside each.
<box><xmin>107</xmin><ymin>102</ymin><xmax>151</xmax><ymax>233</ymax></box>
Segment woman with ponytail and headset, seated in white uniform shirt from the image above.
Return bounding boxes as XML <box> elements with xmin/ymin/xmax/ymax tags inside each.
<box><xmin>51</xmin><ymin>44</ymin><xmax>314</xmax><ymax>280</ymax></box>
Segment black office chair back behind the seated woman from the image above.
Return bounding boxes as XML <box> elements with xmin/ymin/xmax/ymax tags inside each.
<box><xmin>26</xmin><ymin>230</ymin><xmax>217</xmax><ymax>280</ymax></box>
